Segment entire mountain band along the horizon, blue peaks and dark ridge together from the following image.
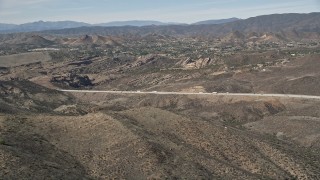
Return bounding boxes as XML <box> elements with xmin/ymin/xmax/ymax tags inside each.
<box><xmin>0</xmin><ymin>12</ymin><xmax>320</xmax><ymax>37</ymax></box>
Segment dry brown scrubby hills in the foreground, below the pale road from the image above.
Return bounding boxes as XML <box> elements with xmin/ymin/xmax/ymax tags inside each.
<box><xmin>0</xmin><ymin>82</ymin><xmax>320</xmax><ymax>179</ymax></box>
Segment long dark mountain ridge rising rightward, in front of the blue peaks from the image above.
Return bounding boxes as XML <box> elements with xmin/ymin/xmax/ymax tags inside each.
<box><xmin>31</xmin><ymin>13</ymin><xmax>320</xmax><ymax>40</ymax></box>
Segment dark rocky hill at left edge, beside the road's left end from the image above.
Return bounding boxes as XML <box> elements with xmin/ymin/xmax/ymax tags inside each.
<box><xmin>0</xmin><ymin>80</ymin><xmax>79</xmax><ymax>114</ymax></box>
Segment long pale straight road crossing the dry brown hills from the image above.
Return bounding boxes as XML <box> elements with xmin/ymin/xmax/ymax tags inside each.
<box><xmin>58</xmin><ymin>89</ymin><xmax>320</xmax><ymax>100</ymax></box>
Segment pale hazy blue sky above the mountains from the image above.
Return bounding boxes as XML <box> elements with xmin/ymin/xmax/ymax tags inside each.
<box><xmin>0</xmin><ymin>0</ymin><xmax>320</xmax><ymax>24</ymax></box>
